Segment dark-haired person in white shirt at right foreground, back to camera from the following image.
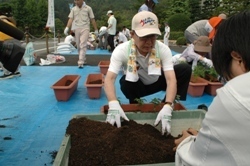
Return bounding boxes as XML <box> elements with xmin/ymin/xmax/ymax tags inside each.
<box><xmin>175</xmin><ymin>11</ymin><xmax>250</xmax><ymax>166</ymax></box>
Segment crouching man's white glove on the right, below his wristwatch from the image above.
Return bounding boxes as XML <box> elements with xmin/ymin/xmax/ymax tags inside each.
<box><xmin>154</xmin><ymin>104</ymin><xmax>173</xmax><ymax>135</ymax></box>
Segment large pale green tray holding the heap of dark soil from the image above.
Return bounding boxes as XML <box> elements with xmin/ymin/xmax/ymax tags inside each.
<box><xmin>53</xmin><ymin>110</ymin><xmax>206</xmax><ymax>166</ymax></box>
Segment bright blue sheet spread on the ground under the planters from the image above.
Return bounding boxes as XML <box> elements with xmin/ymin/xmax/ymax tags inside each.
<box><xmin>0</xmin><ymin>49</ymin><xmax>213</xmax><ymax>166</ymax></box>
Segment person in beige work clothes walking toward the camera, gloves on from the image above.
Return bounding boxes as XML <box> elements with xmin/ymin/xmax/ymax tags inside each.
<box><xmin>64</xmin><ymin>0</ymin><xmax>98</xmax><ymax>68</ymax></box>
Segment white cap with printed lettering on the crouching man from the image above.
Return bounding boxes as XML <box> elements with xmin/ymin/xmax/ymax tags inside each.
<box><xmin>132</xmin><ymin>11</ymin><xmax>161</xmax><ymax>37</ymax></box>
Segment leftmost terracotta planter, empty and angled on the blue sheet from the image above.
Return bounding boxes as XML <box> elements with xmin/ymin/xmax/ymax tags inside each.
<box><xmin>51</xmin><ymin>75</ymin><xmax>81</xmax><ymax>101</ymax></box>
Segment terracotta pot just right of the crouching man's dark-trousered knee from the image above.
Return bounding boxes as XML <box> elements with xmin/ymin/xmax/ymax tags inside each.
<box><xmin>188</xmin><ymin>76</ymin><xmax>208</xmax><ymax>97</ymax></box>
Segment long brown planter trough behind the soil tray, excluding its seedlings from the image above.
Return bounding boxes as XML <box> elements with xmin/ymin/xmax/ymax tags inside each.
<box><xmin>101</xmin><ymin>103</ymin><xmax>186</xmax><ymax>114</ymax></box>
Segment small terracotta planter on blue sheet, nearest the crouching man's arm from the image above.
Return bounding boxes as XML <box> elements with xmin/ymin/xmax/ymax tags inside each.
<box><xmin>85</xmin><ymin>73</ymin><xmax>104</xmax><ymax>99</ymax></box>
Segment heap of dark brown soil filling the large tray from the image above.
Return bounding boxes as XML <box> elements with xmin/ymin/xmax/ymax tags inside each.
<box><xmin>66</xmin><ymin>118</ymin><xmax>179</xmax><ymax>166</ymax></box>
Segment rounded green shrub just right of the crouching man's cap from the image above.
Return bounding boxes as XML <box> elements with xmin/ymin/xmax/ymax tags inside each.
<box><xmin>168</xmin><ymin>13</ymin><xmax>192</xmax><ymax>32</ymax></box>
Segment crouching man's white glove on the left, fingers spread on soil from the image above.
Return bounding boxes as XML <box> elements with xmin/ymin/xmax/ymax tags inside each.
<box><xmin>106</xmin><ymin>100</ymin><xmax>129</xmax><ymax>127</ymax></box>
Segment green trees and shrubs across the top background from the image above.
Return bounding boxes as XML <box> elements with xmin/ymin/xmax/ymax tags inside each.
<box><xmin>0</xmin><ymin>0</ymin><xmax>250</xmax><ymax>37</ymax></box>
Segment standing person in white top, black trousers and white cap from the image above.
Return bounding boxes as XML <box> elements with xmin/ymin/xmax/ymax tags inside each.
<box><xmin>107</xmin><ymin>10</ymin><xmax>117</xmax><ymax>52</ymax></box>
